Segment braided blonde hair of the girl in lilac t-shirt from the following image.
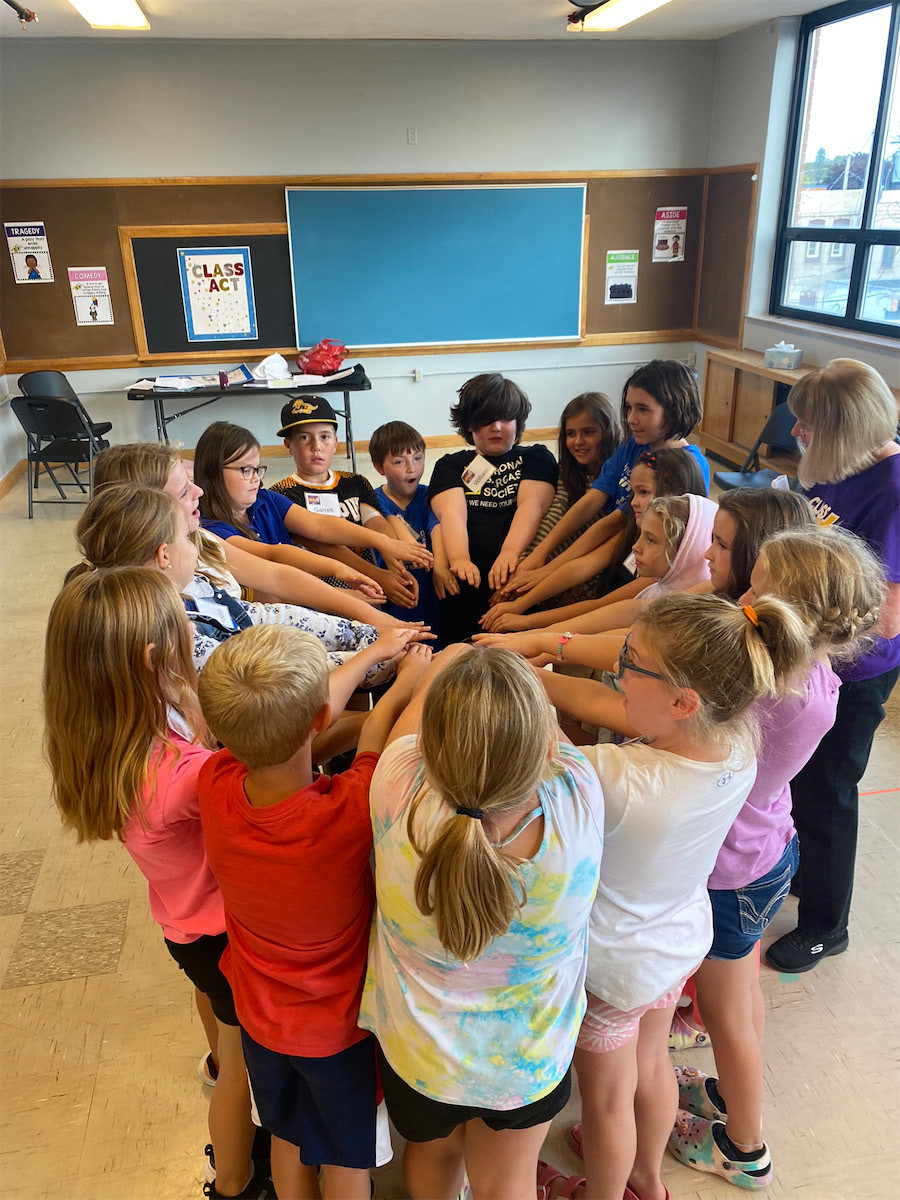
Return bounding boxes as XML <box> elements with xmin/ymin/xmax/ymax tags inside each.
<box><xmin>758</xmin><ymin>526</ymin><xmax>886</xmax><ymax>661</ymax></box>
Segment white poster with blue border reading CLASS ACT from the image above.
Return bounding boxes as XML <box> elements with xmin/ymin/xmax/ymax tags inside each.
<box><xmin>178</xmin><ymin>246</ymin><xmax>259</xmax><ymax>342</ymax></box>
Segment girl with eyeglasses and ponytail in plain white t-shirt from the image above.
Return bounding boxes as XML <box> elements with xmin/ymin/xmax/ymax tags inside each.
<box><xmin>538</xmin><ymin>594</ymin><xmax>810</xmax><ymax>1200</ymax></box>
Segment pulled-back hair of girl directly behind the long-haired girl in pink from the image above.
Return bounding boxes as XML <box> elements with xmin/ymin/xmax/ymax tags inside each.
<box><xmin>66</xmin><ymin>484</ymin><xmax>184</xmax><ymax>590</ymax></box>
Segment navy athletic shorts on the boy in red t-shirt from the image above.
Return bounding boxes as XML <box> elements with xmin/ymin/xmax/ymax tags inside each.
<box><xmin>241</xmin><ymin>1030</ymin><xmax>378</xmax><ymax>1170</ymax></box>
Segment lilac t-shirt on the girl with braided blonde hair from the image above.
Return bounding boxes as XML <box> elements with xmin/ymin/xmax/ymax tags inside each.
<box><xmin>707</xmin><ymin>661</ymin><xmax>841</xmax><ymax>890</ymax></box>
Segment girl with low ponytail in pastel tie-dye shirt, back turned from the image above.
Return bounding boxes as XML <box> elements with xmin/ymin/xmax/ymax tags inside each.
<box><xmin>360</xmin><ymin>646</ymin><xmax>602</xmax><ymax>1200</ymax></box>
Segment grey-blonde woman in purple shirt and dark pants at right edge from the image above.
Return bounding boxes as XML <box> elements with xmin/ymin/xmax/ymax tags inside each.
<box><xmin>767</xmin><ymin>359</ymin><xmax>900</xmax><ymax>972</ymax></box>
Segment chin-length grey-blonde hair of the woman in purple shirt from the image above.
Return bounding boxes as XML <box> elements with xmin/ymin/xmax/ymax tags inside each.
<box><xmin>787</xmin><ymin>359</ymin><xmax>898</xmax><ymax>487</ymax></box>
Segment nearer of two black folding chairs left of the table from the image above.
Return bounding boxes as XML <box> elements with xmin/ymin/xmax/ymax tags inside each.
<box><xmin>10</xmin><ymin>396</ymin><xmax>106</xmax><ymax>520</ymax></box>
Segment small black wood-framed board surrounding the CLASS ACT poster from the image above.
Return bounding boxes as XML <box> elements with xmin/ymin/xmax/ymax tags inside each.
<box><xmin>132</xmin><ymin>234</ymin><xmax>294</xmax><ymax>356</ymax></box>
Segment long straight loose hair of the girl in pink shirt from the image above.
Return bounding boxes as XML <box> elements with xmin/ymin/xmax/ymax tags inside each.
<box><xmin>43</xmin><ymin>566</ymin><xmax>204</xmax><ymax>841</ymax></box>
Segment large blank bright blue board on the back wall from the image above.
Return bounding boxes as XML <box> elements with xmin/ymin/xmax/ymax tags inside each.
<box><xmin>286</xmin><ymin>184</ymin><xmax>586</xmax><ymax>349</ymax></box>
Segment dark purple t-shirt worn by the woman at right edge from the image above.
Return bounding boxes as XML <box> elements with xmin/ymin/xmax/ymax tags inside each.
<box><xmin>805</xmin><ymin>454</ymin><xmax>900</xmax><ymax>683</ymax></box>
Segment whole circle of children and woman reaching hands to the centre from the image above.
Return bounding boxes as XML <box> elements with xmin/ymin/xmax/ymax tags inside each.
<box><xmin>44</xmin><ymin>360</ymin><xmax>900</xmax><ymax>1200</ymax></box>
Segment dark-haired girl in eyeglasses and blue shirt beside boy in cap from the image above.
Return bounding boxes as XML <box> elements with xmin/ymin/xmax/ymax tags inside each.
<box><xmin>193</xmin><ymin>421</ymin><xmax>432</xmax><ymax>595</ymax></box>
